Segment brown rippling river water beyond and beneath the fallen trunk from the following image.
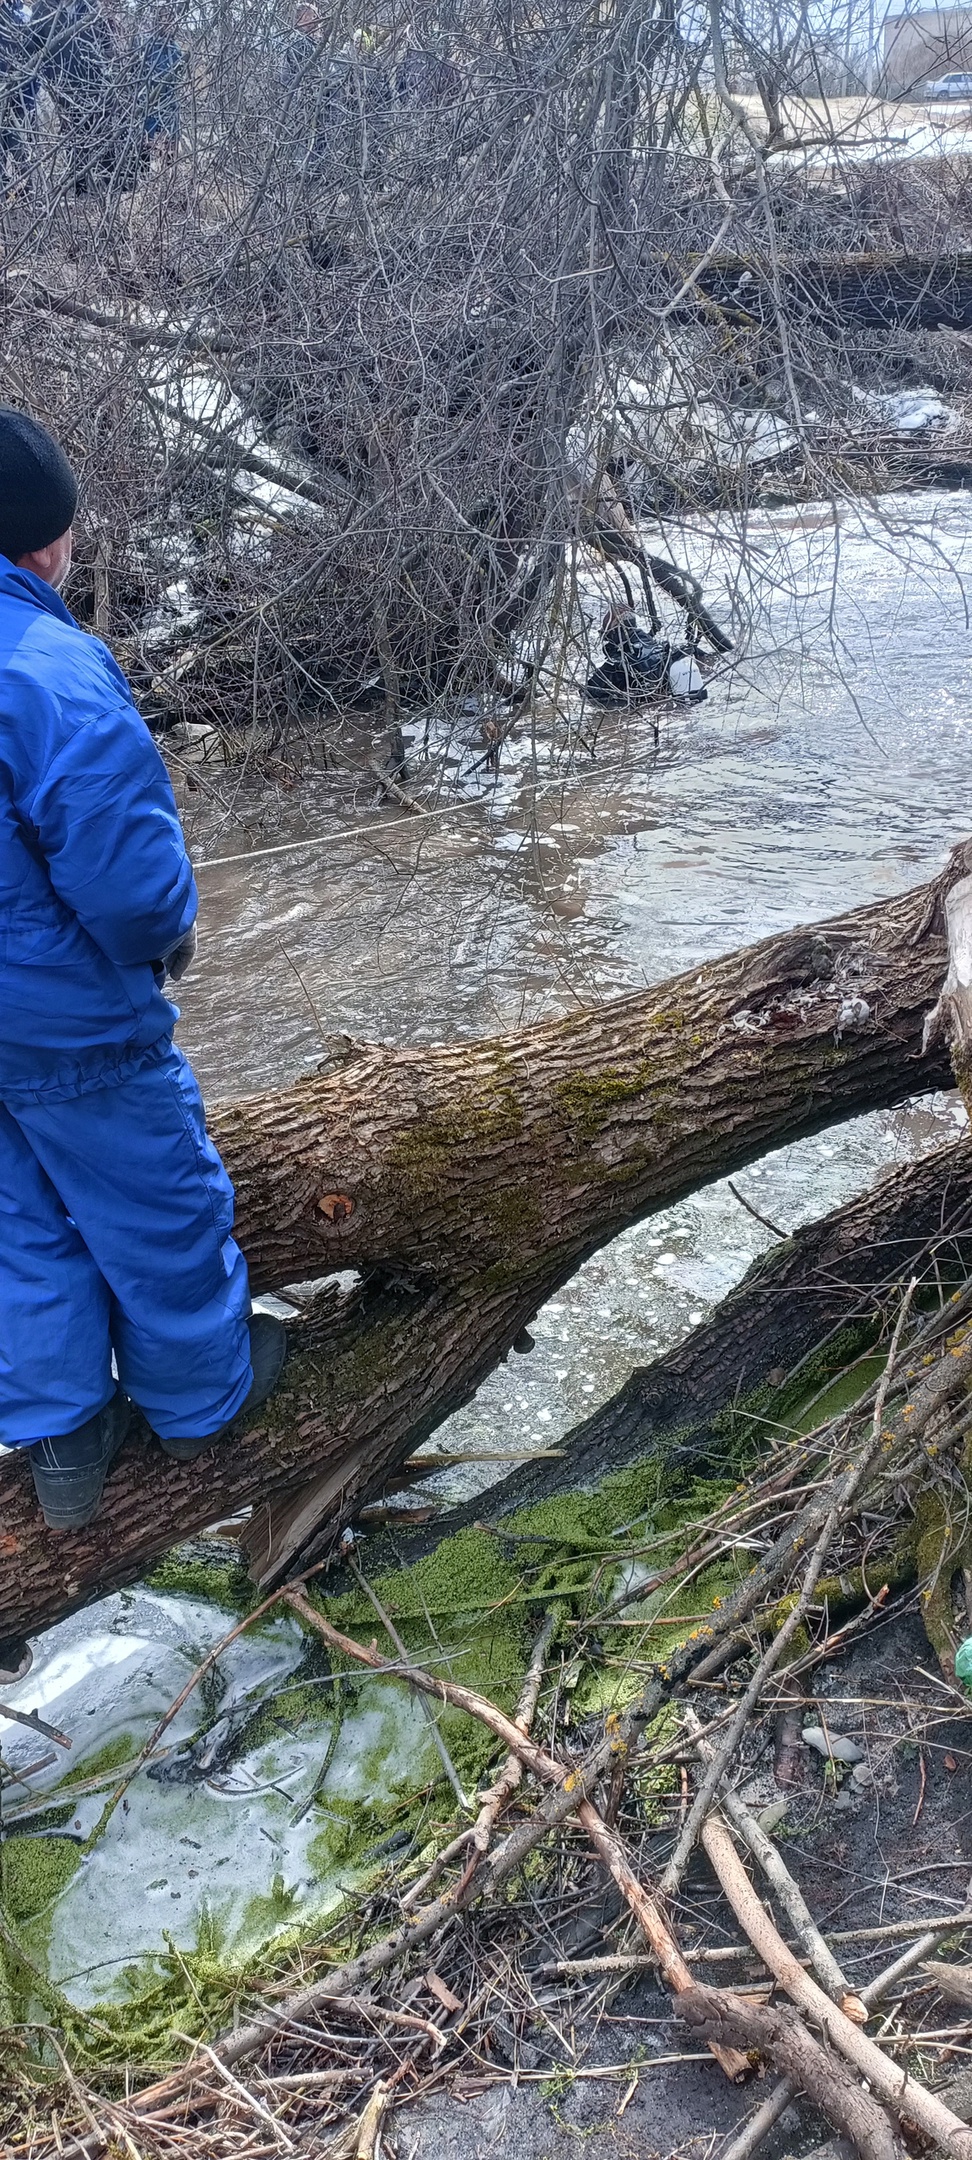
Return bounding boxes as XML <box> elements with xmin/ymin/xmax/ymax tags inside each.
<box><xmin>181</xmin><ymin>495</ymin><xmax>972</xmax><ymax>1488</ymax></box>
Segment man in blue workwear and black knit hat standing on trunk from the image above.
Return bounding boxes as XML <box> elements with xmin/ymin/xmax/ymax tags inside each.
<box><xmin>0</xmin><ymin>406</ymin><xmax>285</xmax><ymax>1529</ymax></box>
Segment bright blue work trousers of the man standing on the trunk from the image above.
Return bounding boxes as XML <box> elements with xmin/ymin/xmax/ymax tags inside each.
<box><xmin>0</xmin><ymin>1043</ymin><xmax>251</xmax><ymax>1447</ymax></box>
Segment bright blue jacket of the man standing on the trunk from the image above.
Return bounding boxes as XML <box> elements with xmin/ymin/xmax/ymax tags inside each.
<box><xmin>0</xmin><ymin>555</ymin><xmax>197</xmax><ymax>1099</ymax></box>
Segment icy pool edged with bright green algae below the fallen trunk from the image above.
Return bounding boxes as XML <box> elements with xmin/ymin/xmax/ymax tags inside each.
<box><xmin>6</xmin><ymin>1341</ymin><xmax>902</xmax><ymax>2069</ymax></box>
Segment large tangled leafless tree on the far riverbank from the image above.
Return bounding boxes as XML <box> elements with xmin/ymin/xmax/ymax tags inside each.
<box><xmin>0</xmin><ymin>0</ymin><xmax>968</xmax><ymax>773</ymax></box>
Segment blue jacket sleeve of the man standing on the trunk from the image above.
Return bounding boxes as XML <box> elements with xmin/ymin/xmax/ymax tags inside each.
<box><xmin>30</xmin><ymin>700</ymin><xmax>197</xmax><ymax>968</ymax></box>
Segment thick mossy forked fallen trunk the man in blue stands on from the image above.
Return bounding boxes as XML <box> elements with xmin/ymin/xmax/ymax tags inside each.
<box><xmin>0</xmin><ymin>851</ymin><xmax>966</xmax><ymax>1639</ymax></box>
